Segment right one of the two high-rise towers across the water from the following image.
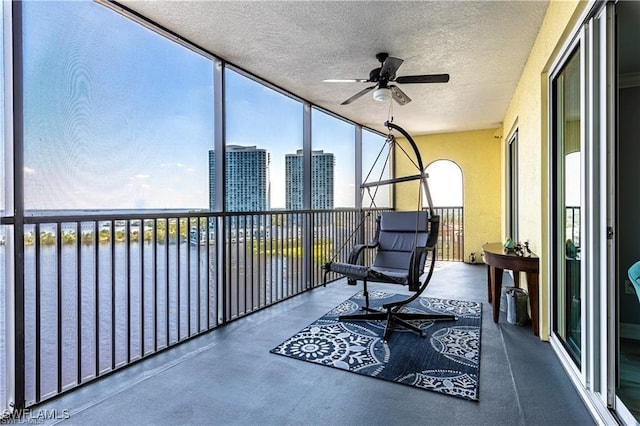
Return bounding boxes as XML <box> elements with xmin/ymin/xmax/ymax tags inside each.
<box><xmin>285</xmin><ymin>149</ymin><xmax>335</xmax><ymax>210</ymax></box>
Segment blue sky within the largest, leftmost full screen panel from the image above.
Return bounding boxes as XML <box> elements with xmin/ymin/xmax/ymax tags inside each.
<box><xmin>24</xmin><ymin>2</ymin><xmax>213</xmax><ymax>208</ymax></box>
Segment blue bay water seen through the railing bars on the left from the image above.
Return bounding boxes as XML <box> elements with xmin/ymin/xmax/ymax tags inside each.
<box><xmin>0</xmin><ymin>211</ymin><xmax>318</xmax><ymax>403</ymax></box>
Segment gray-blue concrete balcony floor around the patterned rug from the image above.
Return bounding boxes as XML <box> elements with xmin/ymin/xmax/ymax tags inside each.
<box><xmin>35</xmin><ymin>263</ymin><xmax>594</xmax><ymax>425</ymax></box>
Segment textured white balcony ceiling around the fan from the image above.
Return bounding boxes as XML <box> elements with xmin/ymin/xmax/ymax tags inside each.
<box><xmin>115</xmin><ymin>0</ymin><xmax>548</xmax><ymax>135</ymax></box>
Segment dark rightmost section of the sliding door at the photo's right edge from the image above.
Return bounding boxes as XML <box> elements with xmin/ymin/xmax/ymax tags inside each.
<box><xmin>612</xmin><ymin>1</ymin><xmax>640</xmax><ymax>421</ymax></box>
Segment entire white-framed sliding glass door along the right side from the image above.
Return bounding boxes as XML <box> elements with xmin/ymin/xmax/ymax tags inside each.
<box><xmin>549</xmin><ymin>1</ymin><xmax>640</xmax><ymax>424</ymax></box>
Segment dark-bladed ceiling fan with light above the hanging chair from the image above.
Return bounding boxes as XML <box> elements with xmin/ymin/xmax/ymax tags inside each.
<box><xmin>324</xmin><ymin>53</ymin><xmax>449</xmax><ymax>105</ymax></box>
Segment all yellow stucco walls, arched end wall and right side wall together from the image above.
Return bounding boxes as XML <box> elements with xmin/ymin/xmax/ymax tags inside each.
<box><xmin>396</xmin><ymin>0</ymin><xmax>589</xmax><ymax>340</ymax></box>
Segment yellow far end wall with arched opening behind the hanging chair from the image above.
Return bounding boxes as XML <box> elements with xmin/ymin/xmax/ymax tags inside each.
<box><xmin>396</xmin><ymin>129</ymin><xmax>502</xmax><ymax>262</ymax></box>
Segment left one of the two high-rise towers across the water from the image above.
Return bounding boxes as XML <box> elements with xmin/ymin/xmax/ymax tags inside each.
<box><xmin>209</xmin><ymin>145</ymin><xmax>271</xmax><ymax>212</ymax></box>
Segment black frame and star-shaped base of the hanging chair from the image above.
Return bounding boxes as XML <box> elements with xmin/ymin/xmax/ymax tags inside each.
<box><xmin>323</xmin><ymin>121</ymin><xmax>457</xmax><ymax>341</ymax></box>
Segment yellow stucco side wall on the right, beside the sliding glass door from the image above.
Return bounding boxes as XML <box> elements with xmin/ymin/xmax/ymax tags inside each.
<box><xmin>501</xmin><ymin>0</ymin><xmax>587</xmax><ymax>340</ymax></box>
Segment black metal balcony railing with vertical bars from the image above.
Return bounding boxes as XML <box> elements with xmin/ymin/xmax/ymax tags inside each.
<box><xmin>0</xmin><ymin>208</ymin><xmax>463</xmax><ymax>406</ymax></box>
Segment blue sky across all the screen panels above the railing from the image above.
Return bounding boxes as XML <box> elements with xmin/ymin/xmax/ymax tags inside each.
<box><xmin>17</xmin><ymin>1</ymin><xmax>458</xmax><ymax>209</ymax></box>
